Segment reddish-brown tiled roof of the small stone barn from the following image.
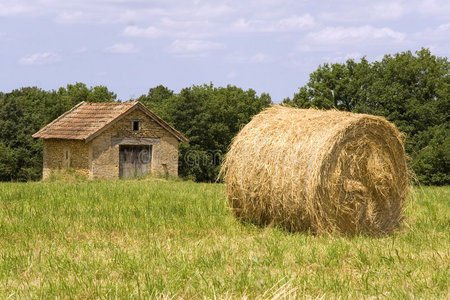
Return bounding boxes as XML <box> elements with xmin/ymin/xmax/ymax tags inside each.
<box><xmin>33</xmin><ymin>102</ymin><xmax>187</xmax><ymax>142</ymax></box>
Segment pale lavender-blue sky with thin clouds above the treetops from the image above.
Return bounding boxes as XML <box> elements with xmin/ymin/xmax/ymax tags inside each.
<box><xmin>0</xmin><ymin>0</ymin><xmax>450</xmax><ymax>102</ymax></box>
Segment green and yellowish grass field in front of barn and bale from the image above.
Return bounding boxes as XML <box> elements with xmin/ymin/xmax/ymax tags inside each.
<box><xmin>0</xmin><ymin>181</ymin><xmax>450</xmax><ymax>299</ymax></box>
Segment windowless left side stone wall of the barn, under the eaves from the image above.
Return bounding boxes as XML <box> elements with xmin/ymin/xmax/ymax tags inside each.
<box><xmin>42</xmin><ymin>139</ymin><xmax>91</xmax><ymax>179</ymax></box>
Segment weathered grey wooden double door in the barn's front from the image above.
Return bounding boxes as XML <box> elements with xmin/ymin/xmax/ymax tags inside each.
<box><xmin>119</xmin><ymin>145</ymin><xmax>152</xmax><ymax>178</ymax></box>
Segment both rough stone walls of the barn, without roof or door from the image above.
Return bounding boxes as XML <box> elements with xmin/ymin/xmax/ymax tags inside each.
<box><xmin>43</xmin><ymin>109</ymin><xmax>179</xmax><ymax>179</ymax></box>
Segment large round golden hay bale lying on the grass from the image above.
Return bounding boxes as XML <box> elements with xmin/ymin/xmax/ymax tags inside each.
<box><xmin>221</xmin><ymin>106</ymin><xmax>408</xmax><ymax>235</ymax></box>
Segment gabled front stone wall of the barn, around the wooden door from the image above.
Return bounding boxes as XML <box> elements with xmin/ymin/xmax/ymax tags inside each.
<box><xmin>90</xmin><ymin>109</ymin><xmax>178</xmax><ymax>179</ymax></box>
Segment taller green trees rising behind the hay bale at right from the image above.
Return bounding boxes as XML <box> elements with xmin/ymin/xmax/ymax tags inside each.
<box><xmin>283</xmin><ymin>49</ymin><xmax>450</xmax><ymax>184</ymax></box>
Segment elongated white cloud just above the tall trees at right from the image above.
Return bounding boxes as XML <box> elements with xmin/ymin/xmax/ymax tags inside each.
<box><xmin>308</xmin><ymin>25</ymin><xmax>406</xmax><ymax>44</ymax></box>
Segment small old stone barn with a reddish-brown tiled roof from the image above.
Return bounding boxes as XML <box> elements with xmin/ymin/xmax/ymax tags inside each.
<box><xmin>33</xmin><ymin>102</ymin><xmax>187</xmax><ymax>179</ymax></box>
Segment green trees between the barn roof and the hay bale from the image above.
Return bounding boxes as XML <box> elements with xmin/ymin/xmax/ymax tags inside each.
<box><xmin>138</xmin><ymin>84</ymin><xmax>272</xmax><ymax>181</ymax></box>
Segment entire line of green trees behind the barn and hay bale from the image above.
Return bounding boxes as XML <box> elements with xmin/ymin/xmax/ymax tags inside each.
<box><xmin>0</xmin><ymin>49</ymin><xmax>450</xmax><ymax>185</ymax></box>
